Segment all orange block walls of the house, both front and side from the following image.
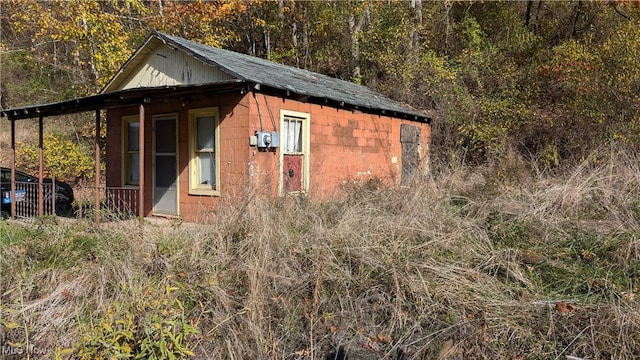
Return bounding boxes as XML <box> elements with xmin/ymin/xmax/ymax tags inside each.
<box><xmin>106</xmin><ymin>94</ymin><xmax>430</xmax><ymax>221</ymax></box>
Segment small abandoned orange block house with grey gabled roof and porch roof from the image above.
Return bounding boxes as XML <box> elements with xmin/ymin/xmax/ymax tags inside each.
<box><xmin>2</xmin><ymin>32</ymin><xmax>431</xmax><ymax>221</ymax></box>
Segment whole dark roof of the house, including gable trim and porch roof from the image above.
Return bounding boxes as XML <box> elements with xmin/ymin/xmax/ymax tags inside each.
<box><xmin>0</xmin><ymin>31</ymin><xmax>431</xmax><ymax>122</ymax></box>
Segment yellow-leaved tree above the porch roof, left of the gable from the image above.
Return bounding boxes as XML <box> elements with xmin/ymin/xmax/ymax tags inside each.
<box><xmin>4</xmin><ymin>0</ymin><xmax>146</xmax><ymax>95</ymax></box>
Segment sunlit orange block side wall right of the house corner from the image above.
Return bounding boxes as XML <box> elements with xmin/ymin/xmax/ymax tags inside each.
<box><xmin>249</xmin><ymin>94</ymin><xmax>431</xmax><ymax>199</ymax></box>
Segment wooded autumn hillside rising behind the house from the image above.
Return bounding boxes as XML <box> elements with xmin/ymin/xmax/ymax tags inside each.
<box><xmin>0</xmin><ymin>0</ymin><xmax>640</xmax><ymax>169</ymax></box>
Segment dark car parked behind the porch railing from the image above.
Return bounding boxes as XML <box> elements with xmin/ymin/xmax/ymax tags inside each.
<box><xmin>0</xmin><ymin>167</ymin><xmax>73</xmax><ymax>215</ymax></box>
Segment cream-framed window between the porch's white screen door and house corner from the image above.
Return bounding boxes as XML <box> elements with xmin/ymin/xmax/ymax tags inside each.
<box><xmin>189</xmin><ymin>107</ymin><xmax>220</xmax><ymax>195</ymax></box>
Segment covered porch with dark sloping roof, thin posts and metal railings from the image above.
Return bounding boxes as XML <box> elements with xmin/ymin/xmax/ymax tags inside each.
<box><xmin>0</xmin><ymin>80</ymin><xmax>248</xmax><ymax>224</ymax></box>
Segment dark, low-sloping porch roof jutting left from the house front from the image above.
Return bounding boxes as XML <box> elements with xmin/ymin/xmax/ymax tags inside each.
<box><xmin>0</xmin><ymin>80</ymin><xmax>246</xmax><ymax>121</ymax></box>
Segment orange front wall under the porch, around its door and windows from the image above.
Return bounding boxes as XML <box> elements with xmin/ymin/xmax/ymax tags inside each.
<box><xmin>106</xmin><ymin>95</ymin><xmax>249</xmax><ymax>221</ymax></box>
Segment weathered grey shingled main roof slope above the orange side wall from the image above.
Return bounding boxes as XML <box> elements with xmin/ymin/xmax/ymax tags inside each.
<box><xmin>151</xmin><ymin>31</ymin><xmax>428</xmax><ymax>120</ymax></box>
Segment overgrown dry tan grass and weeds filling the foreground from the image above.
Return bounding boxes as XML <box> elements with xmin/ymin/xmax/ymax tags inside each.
<box><xmin>0</xmin><ymin>148</ymin><xmax>640</xmax><ymax>359</ymax></box>
